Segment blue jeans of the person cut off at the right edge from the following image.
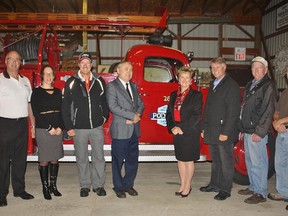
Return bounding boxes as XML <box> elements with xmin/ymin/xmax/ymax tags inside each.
<box><xmin>275</xmin><ymin>130</ymin><xmax>288</xmax><ymax>199</ymax></box>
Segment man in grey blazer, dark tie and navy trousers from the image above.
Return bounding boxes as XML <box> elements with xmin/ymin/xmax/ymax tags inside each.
<box><xmin>107</xmin><ymin>61</ymin><xmax>144</xmax><ymax>198</ymax></box>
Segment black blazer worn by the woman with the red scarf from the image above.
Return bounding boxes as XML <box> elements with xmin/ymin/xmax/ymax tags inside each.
<box><xmin>166</xmin><ymin>89</ymin><xmax>202</xmax><ymax>138</ymax></box>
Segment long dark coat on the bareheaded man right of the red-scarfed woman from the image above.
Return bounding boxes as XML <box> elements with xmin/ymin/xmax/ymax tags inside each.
<box><xmin>202</xmin><ymin>74</ymin><xmax>240</xmax><ymax>144</ymax></box>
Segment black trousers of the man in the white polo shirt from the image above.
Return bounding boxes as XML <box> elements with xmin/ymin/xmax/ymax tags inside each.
<box><xmin>0</xmin><ymin>117</ymin><xmax>28</xmax><ymax>197</ymax></box>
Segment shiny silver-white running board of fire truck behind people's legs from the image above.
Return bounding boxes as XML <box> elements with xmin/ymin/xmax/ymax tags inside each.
<box><xmin>27</xmin><ymin>145</ymin><xmax>206</xmax><ymax>162</ymax></box>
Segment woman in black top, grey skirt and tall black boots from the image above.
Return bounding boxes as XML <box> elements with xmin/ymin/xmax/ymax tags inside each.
<box><xmin>31</xmin><ymin>65</ymin><xmax>64</xmax><ymax>200</ymax></box>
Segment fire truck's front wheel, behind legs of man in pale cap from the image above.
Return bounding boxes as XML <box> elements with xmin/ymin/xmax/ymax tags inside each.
<box><xmin>233</xmin><ymin>133</ymin><xmax>276</xmax><ymax>185</ymax></box>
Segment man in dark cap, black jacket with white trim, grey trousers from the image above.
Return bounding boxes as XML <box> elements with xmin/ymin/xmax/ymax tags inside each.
<box><xmin>62</xmin><ymin>53</ymin><xmax>109</xmax><ymax>197</ymax></box>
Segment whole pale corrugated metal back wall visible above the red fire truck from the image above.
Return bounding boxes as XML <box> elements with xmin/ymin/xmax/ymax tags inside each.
<box><xmin>93</xmin><ymin>24</ymin><xmax>255</xmax><ymax>68</ymax></box>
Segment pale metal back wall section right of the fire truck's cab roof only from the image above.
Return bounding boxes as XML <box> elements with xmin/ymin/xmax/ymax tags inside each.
<box><xmin>168</xmin><ymin>24</ymin><xmax>255</xmax><ymax>68</ymax></box>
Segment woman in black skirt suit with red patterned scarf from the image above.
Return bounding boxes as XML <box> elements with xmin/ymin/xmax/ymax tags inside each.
<box><xmin>166</xmin><ymin>66</ymin><xmax>202</xmax><ymax>197</ymax></box>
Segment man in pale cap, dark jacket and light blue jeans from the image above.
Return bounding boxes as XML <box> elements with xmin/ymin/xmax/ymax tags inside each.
<box><xmin>238</xmin><ymin>56</ymin><xmax>277</xmax><ymax>204</ymax></box>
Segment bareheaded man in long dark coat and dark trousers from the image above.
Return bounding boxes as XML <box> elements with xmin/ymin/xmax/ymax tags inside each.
<box><xmin>200</xmin><ymin>57</ymin><xmax>240</xmax><ymax>200</ymax></box>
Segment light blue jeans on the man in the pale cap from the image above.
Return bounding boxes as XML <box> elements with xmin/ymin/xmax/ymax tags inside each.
<box><xmin>244</xmin><ymin>133</ymin><xmax>268</xmax><ymax>197</ymax></box>
